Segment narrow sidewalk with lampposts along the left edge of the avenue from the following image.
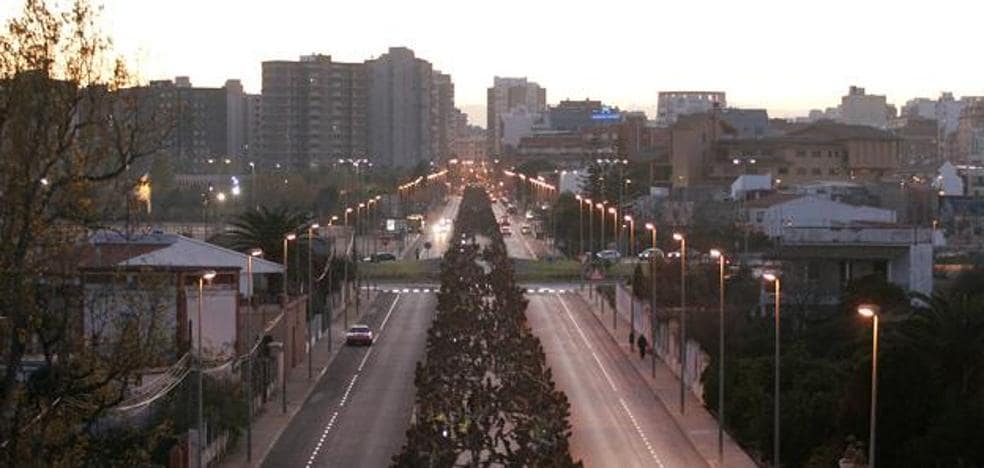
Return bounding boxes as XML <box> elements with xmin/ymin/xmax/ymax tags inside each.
<box><xmin>218</xmin><ymin>291</ymin><xmax>377</xmax><ymax>467</ymax></box>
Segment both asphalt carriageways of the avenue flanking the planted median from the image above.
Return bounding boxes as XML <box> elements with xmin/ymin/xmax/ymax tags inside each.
<box><xmin>263</xmin><ymin>198</ymin><xmax>707</xmax><ymax>468</ymax></box>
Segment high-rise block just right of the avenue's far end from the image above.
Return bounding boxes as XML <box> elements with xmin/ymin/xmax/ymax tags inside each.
<box><xmin>486</xmin><ymin>76</ymin><xmax>547</xmax><ymax>155</ymax></box>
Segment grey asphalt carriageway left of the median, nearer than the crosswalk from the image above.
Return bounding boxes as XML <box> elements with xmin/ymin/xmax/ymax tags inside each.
<box><xmin>263</xmin><ymin>293</ymin><xmax>436</xmax><ymax>467</ymax></box>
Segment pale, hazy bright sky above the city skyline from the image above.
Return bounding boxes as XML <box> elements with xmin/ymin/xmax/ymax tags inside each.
<box><xmin>0</xmin><ymin>0</ymin><xmax>984</xmax><ymax>125</ymax></box>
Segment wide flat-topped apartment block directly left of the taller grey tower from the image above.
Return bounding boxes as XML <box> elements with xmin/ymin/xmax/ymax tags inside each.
<box><xmin>259</xmin><ymin>55</ymin><xmax>368</xmax><ymax>168</ymax></box>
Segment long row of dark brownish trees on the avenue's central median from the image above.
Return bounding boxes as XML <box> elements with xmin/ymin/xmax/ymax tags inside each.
<box><xmin>393</xmin><ymin>187</ymin><xmax>580</xmax><ymax>467</ymax></box>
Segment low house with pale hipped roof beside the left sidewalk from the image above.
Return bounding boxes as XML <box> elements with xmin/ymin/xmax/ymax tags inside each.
<box><xmin>81</xmin><ymin>232</ymin><xmax>283</xmax><ymax>359</ymax></box>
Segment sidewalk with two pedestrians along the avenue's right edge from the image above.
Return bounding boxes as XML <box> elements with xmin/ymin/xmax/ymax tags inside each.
<box><xmin>578</xmin><ymin>286</ymin><xmax>757</xmax><ymax>468</ymax></box>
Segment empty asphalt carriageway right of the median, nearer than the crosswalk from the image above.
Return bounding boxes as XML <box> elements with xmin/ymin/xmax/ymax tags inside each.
<box><xmin>526</xmin><ymin>294</ymin><xmax>707</xmax><ymax>468</ymax></box>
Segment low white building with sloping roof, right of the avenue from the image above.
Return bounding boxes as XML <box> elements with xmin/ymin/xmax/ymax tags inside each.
<box><xmin>744</xmin><ymin>193</ymin><xmax>896</xmax><ymax>238</ymax></box>
